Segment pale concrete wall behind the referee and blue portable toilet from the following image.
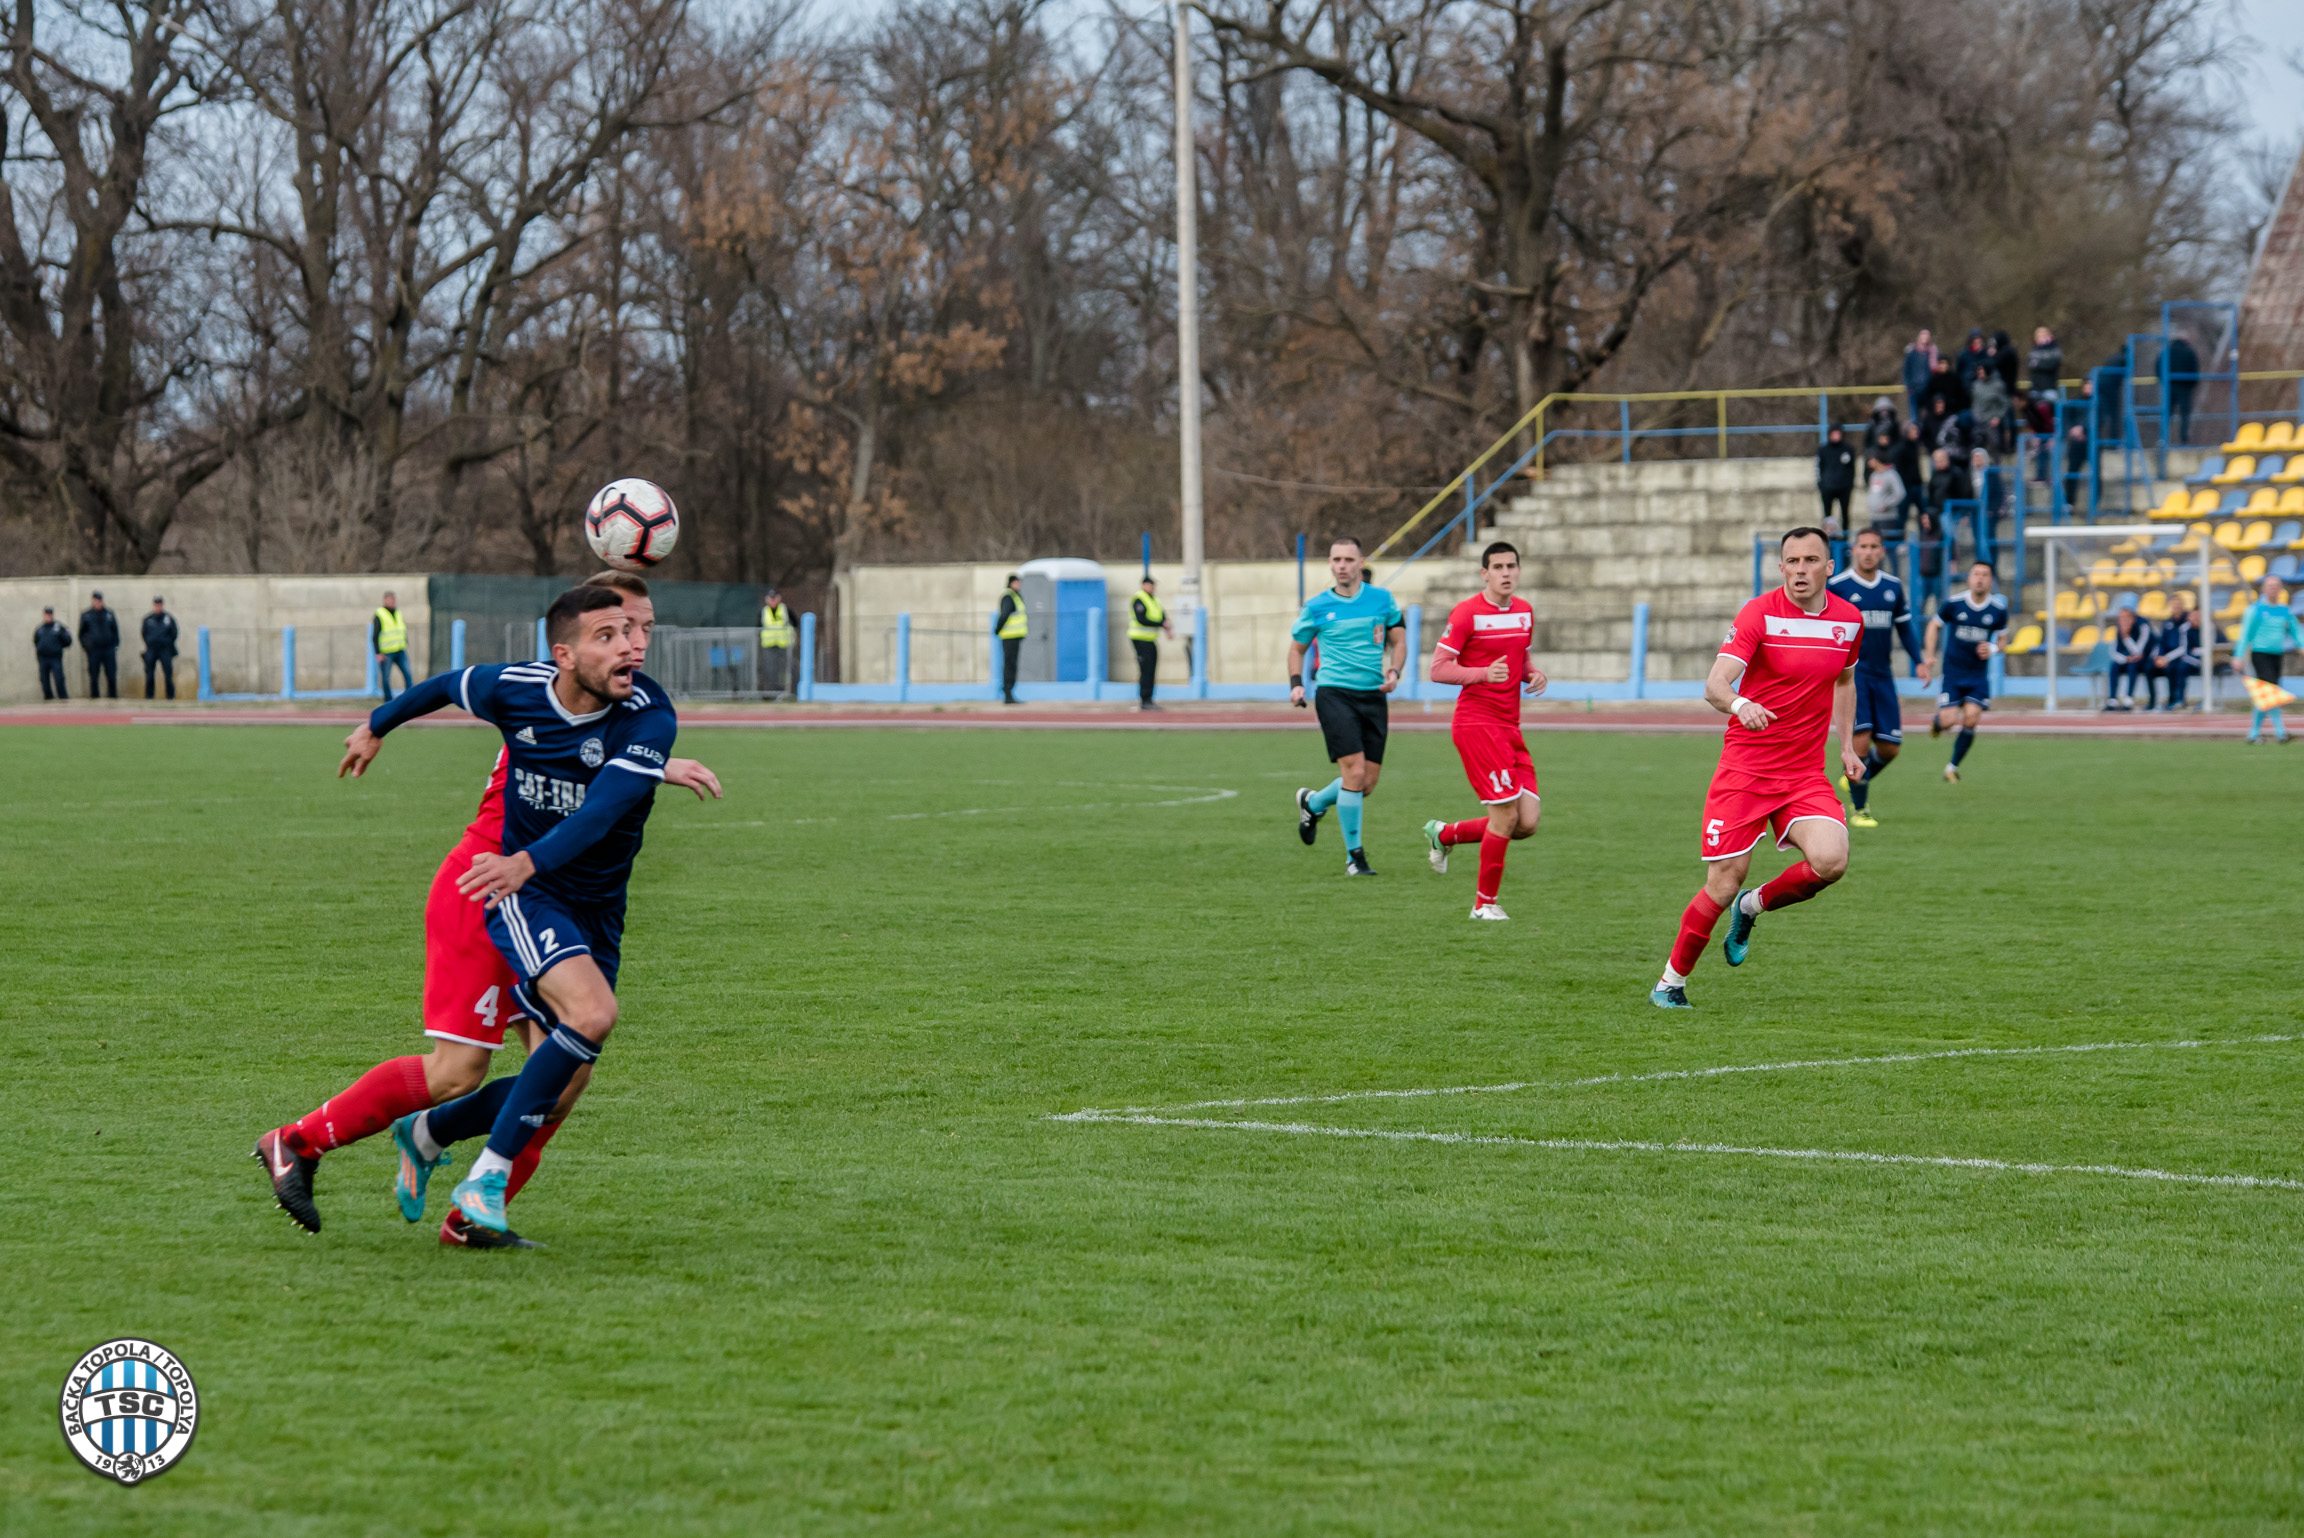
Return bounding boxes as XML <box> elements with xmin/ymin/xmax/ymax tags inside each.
<box><xmin>839</xmin><ymin>550</ymin><xmax>1479</xmax><ymax>684</ymax></box>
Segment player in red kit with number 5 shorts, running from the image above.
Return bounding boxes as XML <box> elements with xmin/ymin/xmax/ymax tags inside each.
<box><xmin>1647</xmin><ymin>527</ymin><xmax>1864</xmax><ymax>1008</ymax></box>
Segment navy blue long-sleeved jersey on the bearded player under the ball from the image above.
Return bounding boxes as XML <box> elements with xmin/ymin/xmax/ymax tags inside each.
<box><xmin>369</xmin><ymin>663</ymin><xmax>680</xmax><ymax>907</ymax></box>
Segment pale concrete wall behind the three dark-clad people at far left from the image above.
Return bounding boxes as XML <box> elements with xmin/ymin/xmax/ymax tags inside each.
<box><xmin>0</xmin><ymin>571</ymin><xmax>445</xmax><ymax>700</ymax></box>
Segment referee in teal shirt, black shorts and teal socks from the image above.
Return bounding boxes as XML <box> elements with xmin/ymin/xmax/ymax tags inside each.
<box><xmin>1288</xmin><ymin>534</ymin><xmax>1408</xmax><ymax>875</ymax></box>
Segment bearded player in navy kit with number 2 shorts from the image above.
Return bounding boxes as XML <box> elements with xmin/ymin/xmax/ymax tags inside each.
<box><xmin>346</xmin><ymin>587</ymin><xmax>680</xmax><ymax>1234</ymax></box>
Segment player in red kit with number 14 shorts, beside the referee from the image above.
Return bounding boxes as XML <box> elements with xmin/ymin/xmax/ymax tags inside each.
<box><xmin>1424</xmin><ymin>541</ymin><xmax>1544</xmax><ymax>921</ymax></box>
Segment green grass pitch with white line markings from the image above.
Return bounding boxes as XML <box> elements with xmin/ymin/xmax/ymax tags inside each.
<box><xmin>0</xmin><ymin>725</ymin><xmax>2304</xmax><ymax>1538</ymax></box>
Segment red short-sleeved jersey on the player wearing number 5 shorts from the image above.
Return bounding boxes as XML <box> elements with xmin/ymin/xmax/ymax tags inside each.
<box><xmin>1721</xmin><ymin>587</ymin><xmax>1864</xmax><ymax>781</ymax></box>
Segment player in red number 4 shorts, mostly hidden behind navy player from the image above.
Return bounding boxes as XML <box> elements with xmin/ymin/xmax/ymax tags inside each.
<box><xmin>256</xmin><ymin>571</ymin><xmax>721</xmax><ymax>1248</ymax></box>
